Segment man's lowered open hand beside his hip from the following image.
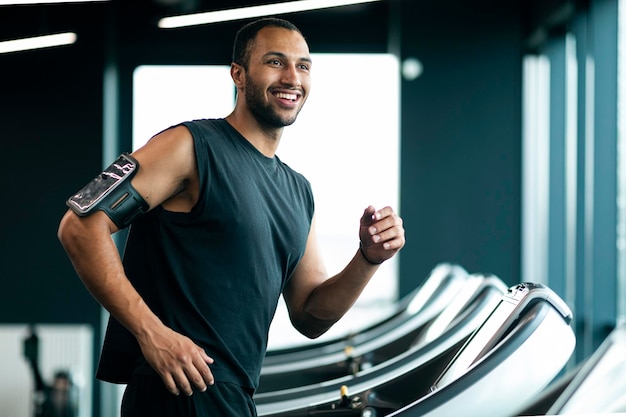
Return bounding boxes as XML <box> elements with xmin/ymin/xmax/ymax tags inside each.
<box><xmin>137</xmin><ymin>326</ymin><xmax>214</xmax><ymax>395</ymax></box>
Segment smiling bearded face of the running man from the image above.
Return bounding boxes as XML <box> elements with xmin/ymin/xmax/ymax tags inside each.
<box><xmin>243</xmin><ymin>27</ymin><xmax>311</xmax><ymax>128</ymax></box>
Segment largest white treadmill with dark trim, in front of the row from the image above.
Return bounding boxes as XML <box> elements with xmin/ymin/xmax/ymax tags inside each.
<box><xmin>388</xmin><ymin>283</ymin><xmax>576</xmax><ymax>417</ymax></box>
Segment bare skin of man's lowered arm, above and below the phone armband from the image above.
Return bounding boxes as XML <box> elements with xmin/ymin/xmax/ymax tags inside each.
<box><xmin>58</xmin><ymin>127</ymin><xmax>213</xmax><ymax>395</ymax></box>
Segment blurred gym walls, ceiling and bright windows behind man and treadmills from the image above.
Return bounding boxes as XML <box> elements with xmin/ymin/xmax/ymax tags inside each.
<box><xmin>0</xmin><ymin>0</ymin><xmax>626</xmax><ymax>417</ymax></box>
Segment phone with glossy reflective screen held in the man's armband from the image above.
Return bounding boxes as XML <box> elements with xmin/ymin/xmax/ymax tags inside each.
<box><xmin>67</xmin><ymin>153</ymin><xmax>138</xmax><ymax>216</ymax></box>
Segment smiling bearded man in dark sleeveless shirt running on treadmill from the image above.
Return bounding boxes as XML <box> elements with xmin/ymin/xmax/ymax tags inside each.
<box><xmin>59</xmin><ymin>18</ymin><xmax>404</xmax><ymax>417</ymax></box>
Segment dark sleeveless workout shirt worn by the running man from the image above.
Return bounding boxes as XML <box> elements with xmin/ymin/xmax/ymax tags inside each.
<box><xmin>97</xmin><ymin>119</ymin><xmax>314</xmax><ymax>389</ymax></box>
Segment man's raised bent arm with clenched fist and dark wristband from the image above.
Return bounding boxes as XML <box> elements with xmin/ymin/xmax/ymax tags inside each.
<box><xmin>283</xmin><ymin>206</ymin><xmax>404</xmax><ymax>338</ymax></box>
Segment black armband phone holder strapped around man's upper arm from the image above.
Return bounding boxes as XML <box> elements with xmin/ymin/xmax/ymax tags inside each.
<box><xmin>66</xmin><ymin>153</ymin><xmax>149</xmax><ymax>229</ymax></box>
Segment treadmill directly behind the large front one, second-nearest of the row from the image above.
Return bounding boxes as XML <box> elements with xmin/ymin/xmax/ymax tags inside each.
<box><xmin>254</xmin><ymin>274</ymin><xmax>507</xmax><ymax>416</ymax></box>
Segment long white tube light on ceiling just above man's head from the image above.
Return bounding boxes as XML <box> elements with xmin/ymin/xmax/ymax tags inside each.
<box><xmin>158</xmin><ymin>0</ymin><xmax>380</xmax><ymax>29</ymax></box>
